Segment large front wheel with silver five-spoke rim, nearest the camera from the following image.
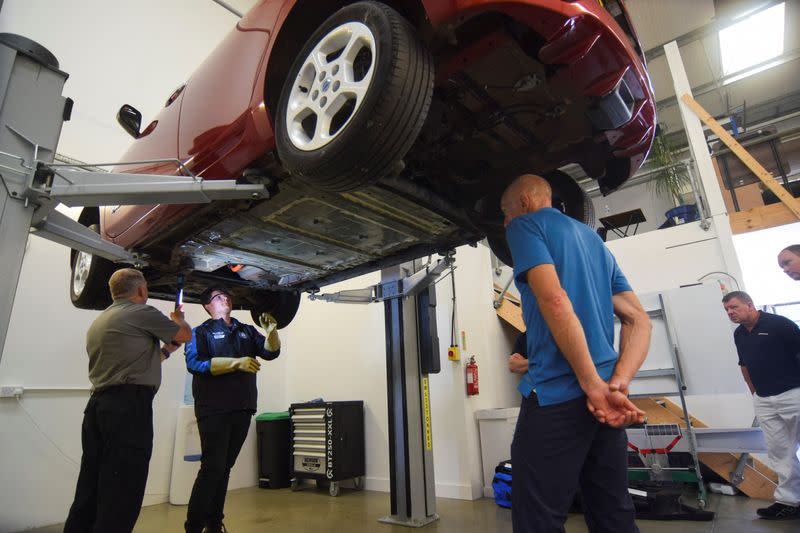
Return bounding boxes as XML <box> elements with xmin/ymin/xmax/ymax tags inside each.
<box><xmin>275</xmin><ymin>2</ymin><xmax>433</xmax><ymax>191</ymax></box>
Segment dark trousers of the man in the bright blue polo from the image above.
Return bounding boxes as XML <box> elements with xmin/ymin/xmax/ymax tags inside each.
<box><xmin>511</xmin><ymin>393</ymin><xmax>639</xmax><ymax>533</ymax></box>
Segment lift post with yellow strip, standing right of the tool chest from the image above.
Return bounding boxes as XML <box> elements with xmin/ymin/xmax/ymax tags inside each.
<box><xmin>311</xmin><ymin>252</ymin><xmax>454</xmax><ymax>527</ymax></box>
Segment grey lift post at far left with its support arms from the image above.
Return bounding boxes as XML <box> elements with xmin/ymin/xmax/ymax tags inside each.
<box><xmin>0</xmin><ymin>34</ymin><xmax>269</xmax><ymax>358</ymax></box>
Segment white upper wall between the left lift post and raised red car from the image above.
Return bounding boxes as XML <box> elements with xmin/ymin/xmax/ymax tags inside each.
<box><xmin>0</xmin><ymin>0</ymin><xmax>256</xmax><ymax>163</ymax></box>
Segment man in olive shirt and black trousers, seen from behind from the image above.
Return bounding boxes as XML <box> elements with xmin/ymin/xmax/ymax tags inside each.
<box><xmin>64</xmin><ymin>268</ymin><xmax>192</xmax><ymax>533</ymax></box>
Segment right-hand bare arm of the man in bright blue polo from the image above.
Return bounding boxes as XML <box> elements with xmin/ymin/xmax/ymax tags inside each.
<box><xmin>609</xmin><ymin>291</ymin><xmax>653</xmax><ymax>394</ymax></box>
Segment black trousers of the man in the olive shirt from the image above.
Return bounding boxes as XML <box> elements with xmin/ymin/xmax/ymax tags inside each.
<box><xmin>64</xmin><ymin>385</ymin><xmax>155</xmax><ymax>533</ymax></box>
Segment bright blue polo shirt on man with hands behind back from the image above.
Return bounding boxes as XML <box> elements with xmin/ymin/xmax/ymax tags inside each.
<box><xmin>506</xmin><ymin>208</ymin><xmax>631</xmax><ymax>406</ymax></box>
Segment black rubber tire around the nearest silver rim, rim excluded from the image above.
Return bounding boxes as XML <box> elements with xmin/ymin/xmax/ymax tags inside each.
<box><xmin>275</xmin><ymin>2</ymin><xmax>434</xmax><ymax>192</ymax></box>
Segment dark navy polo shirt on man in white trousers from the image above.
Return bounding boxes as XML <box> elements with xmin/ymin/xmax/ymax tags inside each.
<box><xmin>733</xmin><ymin>311</ymin><xmax>800</xmax><ymax>398</ymax></box>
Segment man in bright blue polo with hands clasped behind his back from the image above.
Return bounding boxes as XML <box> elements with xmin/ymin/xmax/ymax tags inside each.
<box><xmin>501</xmin><ymin>175</ymin><xmax>651</xmax><ymax>533</ymax></box>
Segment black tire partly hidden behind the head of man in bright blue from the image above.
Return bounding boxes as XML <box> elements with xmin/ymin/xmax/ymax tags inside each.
<box><xmin>486</xmin><ymin>170</ymin><xmax>596</xmax><ymax>267</ymax></box>
